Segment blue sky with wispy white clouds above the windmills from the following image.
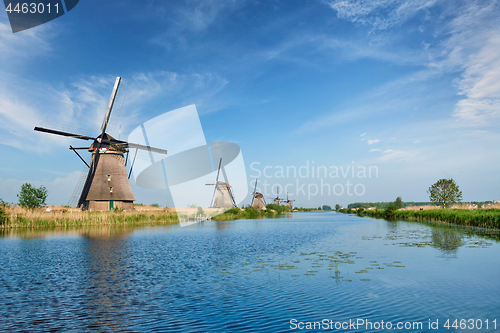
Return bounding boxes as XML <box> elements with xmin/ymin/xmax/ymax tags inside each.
<box><xmin>0</xmin><ymin>0</ymin><xmax>500</xmax><ymax>207</ymax></box>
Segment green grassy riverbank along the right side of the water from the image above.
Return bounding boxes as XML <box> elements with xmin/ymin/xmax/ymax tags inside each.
<box><xmin>339</xmin><ymin>208</ymin><xmax>500</xmax><ymax>229</ymax></box>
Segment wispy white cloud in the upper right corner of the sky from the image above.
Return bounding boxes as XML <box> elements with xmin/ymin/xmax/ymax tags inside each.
<box><xmin>326</xmin><ymin>0</ymin><xmax>500</xmax><ymax>130</ymax></box>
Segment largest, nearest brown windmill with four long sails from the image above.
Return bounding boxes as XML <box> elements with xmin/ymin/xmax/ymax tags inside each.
<box><xmin>35</xmin><ymin>77</ymin><xmax>167</xmax><ymax>210</ymax></box>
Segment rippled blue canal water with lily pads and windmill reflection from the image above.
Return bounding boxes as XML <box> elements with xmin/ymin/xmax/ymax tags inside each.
<box><xmin>0</xmin><ymin>212</ymin><xmax>500</xmax><ymax>332</ymax></box>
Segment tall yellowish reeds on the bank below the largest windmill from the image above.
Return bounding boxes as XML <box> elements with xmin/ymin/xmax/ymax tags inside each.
<box><xmin>0</xmin><ymin>206</ymin><xmax>179</xmax><ymax>228</ymax></box>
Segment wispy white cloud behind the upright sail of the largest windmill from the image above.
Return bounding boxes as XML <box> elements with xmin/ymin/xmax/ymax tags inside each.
<box><xmin>0</xmin><ymin>72</ymin><xmax>228</xmax><ymax>153</ymax></box>
